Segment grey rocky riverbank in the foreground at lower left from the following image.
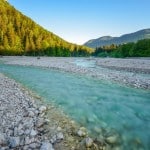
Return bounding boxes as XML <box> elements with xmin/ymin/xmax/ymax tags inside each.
<box><xmin>0</xmin><ymin>74</ymin><xmax>118</xmax><ymax>150</ymax></box>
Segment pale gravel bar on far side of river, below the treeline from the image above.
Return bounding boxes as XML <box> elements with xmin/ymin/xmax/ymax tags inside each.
<box><xmin>0</xmin><ymin>56</ymin><xmax>150</xmax><ymax>89</ymax></box>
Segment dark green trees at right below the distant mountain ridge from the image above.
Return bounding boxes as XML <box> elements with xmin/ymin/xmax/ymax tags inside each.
<box><xmin>92</xmin><ymin>39</ymin><xmax>150</xmax><ymax>58</ymax></box>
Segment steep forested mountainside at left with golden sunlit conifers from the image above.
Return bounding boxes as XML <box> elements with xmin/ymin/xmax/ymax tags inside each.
<box><xmin>0</xmin><ymin>0</ymin><xmax>92</xmax><ymax>56</ymax></box>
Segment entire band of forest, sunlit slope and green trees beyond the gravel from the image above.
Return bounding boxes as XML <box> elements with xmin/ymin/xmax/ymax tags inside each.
<box><xmin>0</xmin><ymin>0</ymin><xmax>150</xmax><ymax>58</ymax></box>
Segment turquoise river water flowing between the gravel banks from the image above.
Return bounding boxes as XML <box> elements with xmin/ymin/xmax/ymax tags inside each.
<box><xmin>0</xmin><ymin>64</ymin><xmax>150</xmax><ymax>150</ymax></box>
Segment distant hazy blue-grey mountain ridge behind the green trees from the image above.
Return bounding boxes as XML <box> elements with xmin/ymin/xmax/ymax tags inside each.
<box><xmin>84</xmin><ymin>28</ymin><xmax>150</xmax><ymax>48</ymax></box>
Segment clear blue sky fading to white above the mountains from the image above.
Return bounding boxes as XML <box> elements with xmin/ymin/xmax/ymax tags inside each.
<box><xmin>8</xmin><ymin>0</ymin><xmax>150</xmax><ymax>44</ymax></box>
